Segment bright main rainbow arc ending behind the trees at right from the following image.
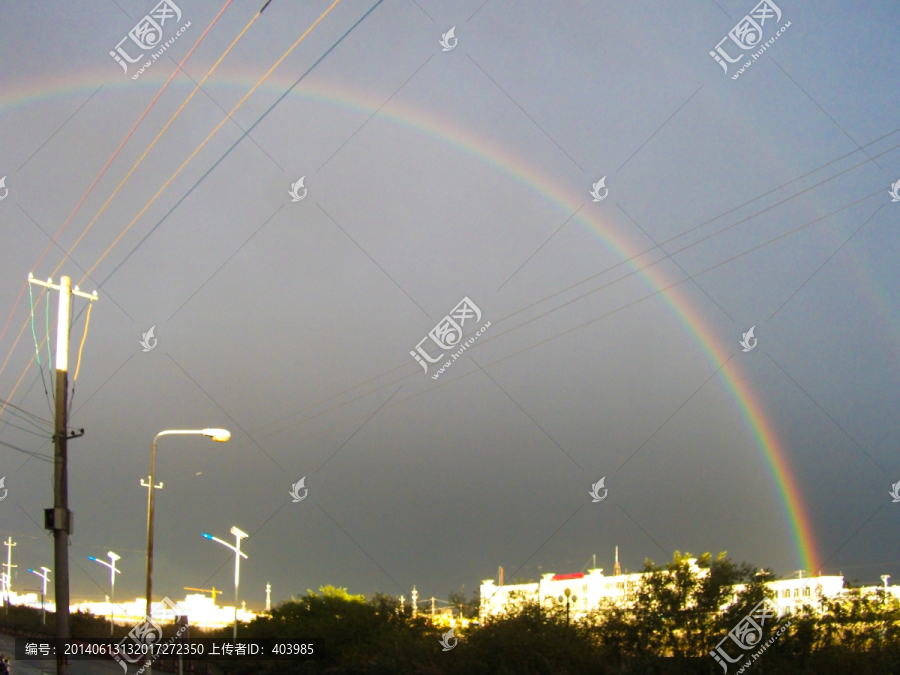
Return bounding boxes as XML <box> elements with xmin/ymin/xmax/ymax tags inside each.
<box><xmin>0</xmin><ymin>71</ymin><xmax>820</xmax><ymax>573</ymax></box>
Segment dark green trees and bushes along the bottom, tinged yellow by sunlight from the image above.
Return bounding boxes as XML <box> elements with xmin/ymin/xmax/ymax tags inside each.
<box><xmin>0</xmin><ymin>552</ymin><xmax>900</xmax><ymax>675</ymax></box>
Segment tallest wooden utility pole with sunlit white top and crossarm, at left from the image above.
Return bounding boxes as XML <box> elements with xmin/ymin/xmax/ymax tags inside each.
<box><xmin>28</xmin><ymin>273</ymin><xmax>98</xmax><ymax>675</ymax></box>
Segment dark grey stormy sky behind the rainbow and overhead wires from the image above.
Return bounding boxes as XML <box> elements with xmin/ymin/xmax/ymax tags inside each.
<box><xmin>0</xmin><ymin>0</ymin><xmax>900</xmax><ymax>608</ymax></box>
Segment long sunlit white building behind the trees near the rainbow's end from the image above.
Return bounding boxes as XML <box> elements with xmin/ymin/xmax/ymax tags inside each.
<box><xmin>479</xmin><ymin>555</ymin><xmax>872</xmax><ymax>621</ymax></box>
